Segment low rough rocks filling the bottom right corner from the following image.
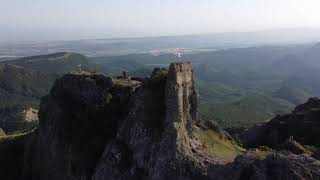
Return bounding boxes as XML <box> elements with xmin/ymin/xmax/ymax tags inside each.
<box><xmin>230</xmin><ymin>152</ymin><xmax>320</xmax><ymax>180</ymax></box>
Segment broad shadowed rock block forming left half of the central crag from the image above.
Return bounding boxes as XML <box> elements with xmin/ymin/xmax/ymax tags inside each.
<box><xmin>32</xmin><ymin>74</ymin><xmax>139</xmax><ymax>180</ymax></box>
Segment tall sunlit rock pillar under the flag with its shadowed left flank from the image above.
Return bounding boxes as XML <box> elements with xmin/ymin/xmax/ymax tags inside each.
<box><xmin>94</xmin><ymin>63</ymin><xmax>209</xmax><ymax>180</ymax></box>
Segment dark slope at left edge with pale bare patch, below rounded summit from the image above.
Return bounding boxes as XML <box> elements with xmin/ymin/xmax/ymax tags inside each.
<box><xmin>0</xmin><ymin>64</ymin><xmax>56</xmax><ymax>133</ymax></box>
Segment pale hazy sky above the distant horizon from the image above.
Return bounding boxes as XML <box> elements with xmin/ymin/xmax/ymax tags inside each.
<box><xmin>0</xmin><ymin>0</ymin><xmax>320</xmax><ymax>41</ymax></box>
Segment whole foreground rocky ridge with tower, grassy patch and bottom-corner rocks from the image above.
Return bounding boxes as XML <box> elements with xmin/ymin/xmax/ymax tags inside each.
<box><xmin>0</xmin><ymin>62</ymin><xmax>320</xmax><ymax>180</ymax></box>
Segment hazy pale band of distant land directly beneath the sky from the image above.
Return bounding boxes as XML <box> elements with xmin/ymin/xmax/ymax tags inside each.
<box><xmin>0</xmin><ymin>28</ymin><xmax>320</xmax><ymax>57</ymax></box>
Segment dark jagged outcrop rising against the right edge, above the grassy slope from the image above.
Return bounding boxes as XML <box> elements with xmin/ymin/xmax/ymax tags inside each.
<box><xmin>244</xmin><ymin>98</ymin><xmax>320</xmax><ymax>148</ymax></box>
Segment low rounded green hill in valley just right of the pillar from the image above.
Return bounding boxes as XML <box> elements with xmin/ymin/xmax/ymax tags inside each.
<box><xmin>200</xmin><ymin>95</ymin><xmax>294</xmax><ymax>128</ymax></box>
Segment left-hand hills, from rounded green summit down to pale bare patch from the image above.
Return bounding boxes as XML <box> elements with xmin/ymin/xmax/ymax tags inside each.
<box><xmin>0</xmin><ymin>52</ymin><xmax>107</xmax><ymax>134</ymax></box>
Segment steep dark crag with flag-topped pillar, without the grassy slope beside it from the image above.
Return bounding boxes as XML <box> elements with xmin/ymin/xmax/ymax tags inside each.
<box><xmin>23</xmin><ymin>63</ymin><xmax>237</xmax><ymax>179</ymax></box>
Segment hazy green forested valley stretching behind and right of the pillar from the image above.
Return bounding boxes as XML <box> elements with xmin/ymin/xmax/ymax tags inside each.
<box><xmin>93</xmin><ymin>45</ymin><xmax>320</xmax><ymax>128</ymax></box>
